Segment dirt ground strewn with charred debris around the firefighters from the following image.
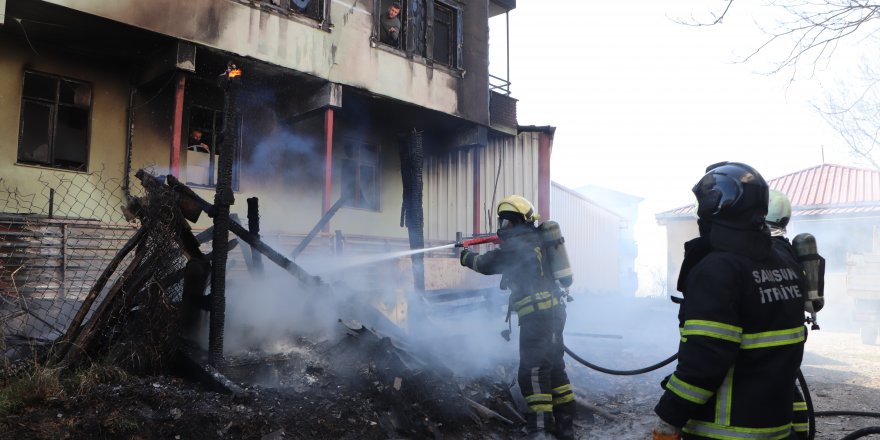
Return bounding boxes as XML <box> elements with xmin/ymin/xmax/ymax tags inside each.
<box><xmin>0</xmin><ymin>304</ymin><xmax>880</xmax><ymax>440</ymax></box>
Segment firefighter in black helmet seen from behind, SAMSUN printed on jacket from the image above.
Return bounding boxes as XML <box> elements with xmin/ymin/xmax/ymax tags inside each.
<box><xmin>654</xmin><ymin>162</ymin><xmax>807</xmax><ymax>439</ymax></box>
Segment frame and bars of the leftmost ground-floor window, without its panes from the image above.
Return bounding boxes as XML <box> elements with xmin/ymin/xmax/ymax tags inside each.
<box><xmin>16</xmin><ymin>69</ymin><xmax>95</xmax><ymax>172</ymax></box>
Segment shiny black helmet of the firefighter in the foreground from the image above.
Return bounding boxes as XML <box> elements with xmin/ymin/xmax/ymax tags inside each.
<box><xmin>692</xmin><ymin>162</ymin><xmax>770</xmax><ymax>229</ymax></box>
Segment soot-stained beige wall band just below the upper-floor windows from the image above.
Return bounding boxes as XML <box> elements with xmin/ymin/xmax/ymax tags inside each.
<box><xmin>47</xmin><ymin>0</ymin><xmax>461</xmax><ymax>114</ymax></box>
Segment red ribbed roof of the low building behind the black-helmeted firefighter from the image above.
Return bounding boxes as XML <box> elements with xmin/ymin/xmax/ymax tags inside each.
<box><xmin>656</xmin><ymin>164</ymin><xmax>880</xmax><ymax>220</ymax></box>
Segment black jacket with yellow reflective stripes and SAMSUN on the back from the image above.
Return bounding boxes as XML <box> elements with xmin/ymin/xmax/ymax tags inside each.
<box><xmin>655</xmin><ymin>232</ymin><xmax>806</xmax><ymax>439</ymax></box>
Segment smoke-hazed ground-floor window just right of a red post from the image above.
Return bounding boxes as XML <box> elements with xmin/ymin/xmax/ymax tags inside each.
<box><xmin>340</xmin><ymin>141</ymin><xmax>379</xmax><ymax>211</ymax></box>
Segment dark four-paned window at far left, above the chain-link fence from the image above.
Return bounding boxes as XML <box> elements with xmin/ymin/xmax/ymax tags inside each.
<box><xmin>18</xmin><ymin>72</ymin><xmax>92</xmax><ymax>171</ymax></box>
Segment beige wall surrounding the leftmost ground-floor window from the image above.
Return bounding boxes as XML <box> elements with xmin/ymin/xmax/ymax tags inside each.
<box><xmin>0</xmin><ymin>37</ymin><xmax>128</xmax><ymax>220</ymax></box>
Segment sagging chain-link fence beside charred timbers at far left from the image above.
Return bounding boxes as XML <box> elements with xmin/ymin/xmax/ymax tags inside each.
<box><xmin>0</xmin><ymin>172</ymin><xmax>189</xmax><ymax>374</ymax></box>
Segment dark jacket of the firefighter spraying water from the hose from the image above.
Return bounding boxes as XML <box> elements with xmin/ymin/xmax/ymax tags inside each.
<box><xmin>462</xmin><ymin>225</ymin><xmax>561</xmax><ymax>319</ymax></box>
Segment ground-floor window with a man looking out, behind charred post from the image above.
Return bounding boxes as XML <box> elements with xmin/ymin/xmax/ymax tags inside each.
<box><xmin>186</xmin><ymin>106</ymin><xmax>241</xmax><ymax>190</ymax></box>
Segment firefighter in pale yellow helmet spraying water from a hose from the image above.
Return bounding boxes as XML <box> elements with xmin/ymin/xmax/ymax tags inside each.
<box><xmin>461</xmin><ymin>195</ymin><xmax>575</xmax><ymax>440</ymax></box>
